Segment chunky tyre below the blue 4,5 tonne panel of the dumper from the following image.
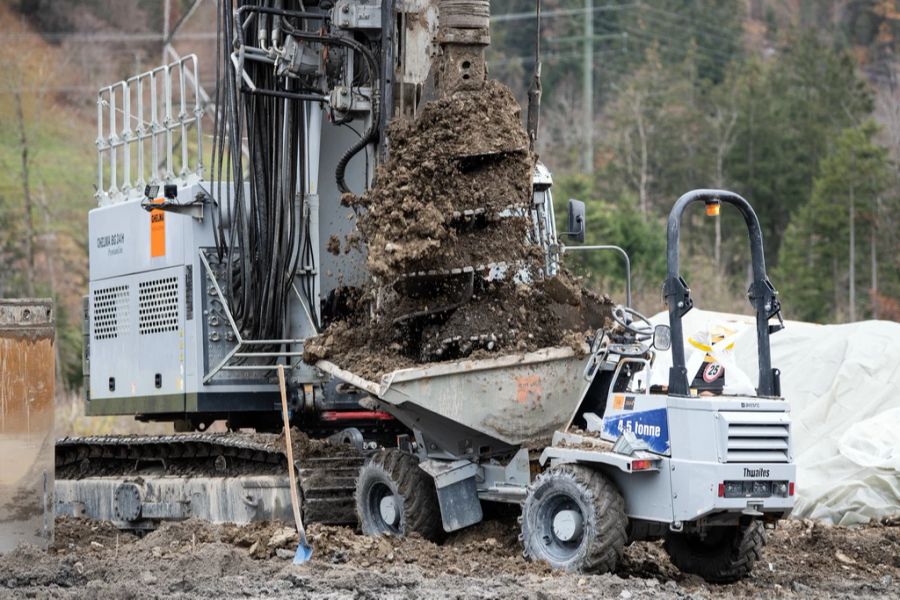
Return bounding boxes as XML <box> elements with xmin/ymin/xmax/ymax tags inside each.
<box><xmin>520</xmin><ymin>464</ymin><xmax>628</xmax><ymax>573</ymax></box>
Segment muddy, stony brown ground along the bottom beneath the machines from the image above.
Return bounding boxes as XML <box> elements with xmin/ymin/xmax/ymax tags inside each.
<box><xmin>0</xmin><ymin>516</ymin><xmax>900</xmax><ymax>599</ymax></box>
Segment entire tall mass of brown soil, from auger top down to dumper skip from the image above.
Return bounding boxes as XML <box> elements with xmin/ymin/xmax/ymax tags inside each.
<box><xmin>304</xmin><ymin>81</ymin><xmax>611</xmax><ymax>380</ymax></box>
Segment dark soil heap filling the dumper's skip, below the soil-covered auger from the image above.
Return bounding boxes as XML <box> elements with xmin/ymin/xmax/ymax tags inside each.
<box><xmin>304</xmin><ymin>273</ymin><xmax>613</xmax><ymax>381</ymax></box>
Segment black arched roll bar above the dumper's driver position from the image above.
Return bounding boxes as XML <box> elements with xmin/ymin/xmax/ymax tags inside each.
<box><xmin>663</xmin><ymin>190</ymin><xmax>784</xmax><ymax>397</ymax></box>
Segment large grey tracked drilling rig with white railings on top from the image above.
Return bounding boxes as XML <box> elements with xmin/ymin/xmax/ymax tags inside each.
<box><xmin>57</xmin><ymin>0</ymin><xmax>556</xmax><ymax>528</ymax></box>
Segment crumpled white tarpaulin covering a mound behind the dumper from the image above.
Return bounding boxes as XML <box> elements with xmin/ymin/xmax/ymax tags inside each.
<box><xmin>652</xmin><ymin>309</ymin><xmax>900</xmax><ymax>525</ymax></box>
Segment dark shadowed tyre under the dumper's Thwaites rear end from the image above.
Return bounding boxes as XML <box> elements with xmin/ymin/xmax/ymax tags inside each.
<box><xmin>663</xmin><ymin>520</ymin><xmax>766</xmax><ymax>583</ymax></box>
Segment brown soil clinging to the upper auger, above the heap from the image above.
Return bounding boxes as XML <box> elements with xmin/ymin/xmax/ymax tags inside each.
<box><xmin>344</xmin><ymin>81</ymin><xmax>534</xmax><ymax>278</ymax></box>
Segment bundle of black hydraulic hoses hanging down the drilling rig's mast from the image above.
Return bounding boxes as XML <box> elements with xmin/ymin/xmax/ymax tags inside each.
<box><xmin>213</xmin><ymin>0</ymin><xmax>380</xmax><ymax>340</ymax></box>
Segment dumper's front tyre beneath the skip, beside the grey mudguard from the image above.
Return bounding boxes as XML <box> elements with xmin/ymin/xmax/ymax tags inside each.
<box><xmin>355</xmin><ymin>449</ymin><xmax>444</xmax><ymax>542</ymax></box>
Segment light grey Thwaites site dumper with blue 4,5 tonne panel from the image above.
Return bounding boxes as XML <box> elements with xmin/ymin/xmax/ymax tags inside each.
<box><xmin>318</xmin><ymin>190</ymin><xmax>796</xmax><ymax>582</ymax></box>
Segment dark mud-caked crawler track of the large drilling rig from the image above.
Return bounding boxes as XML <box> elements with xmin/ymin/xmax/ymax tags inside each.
<box><xmin>56</xmin><ymin>433</ymin><xmax>364</xmax><ymax>525</ymax></box>
